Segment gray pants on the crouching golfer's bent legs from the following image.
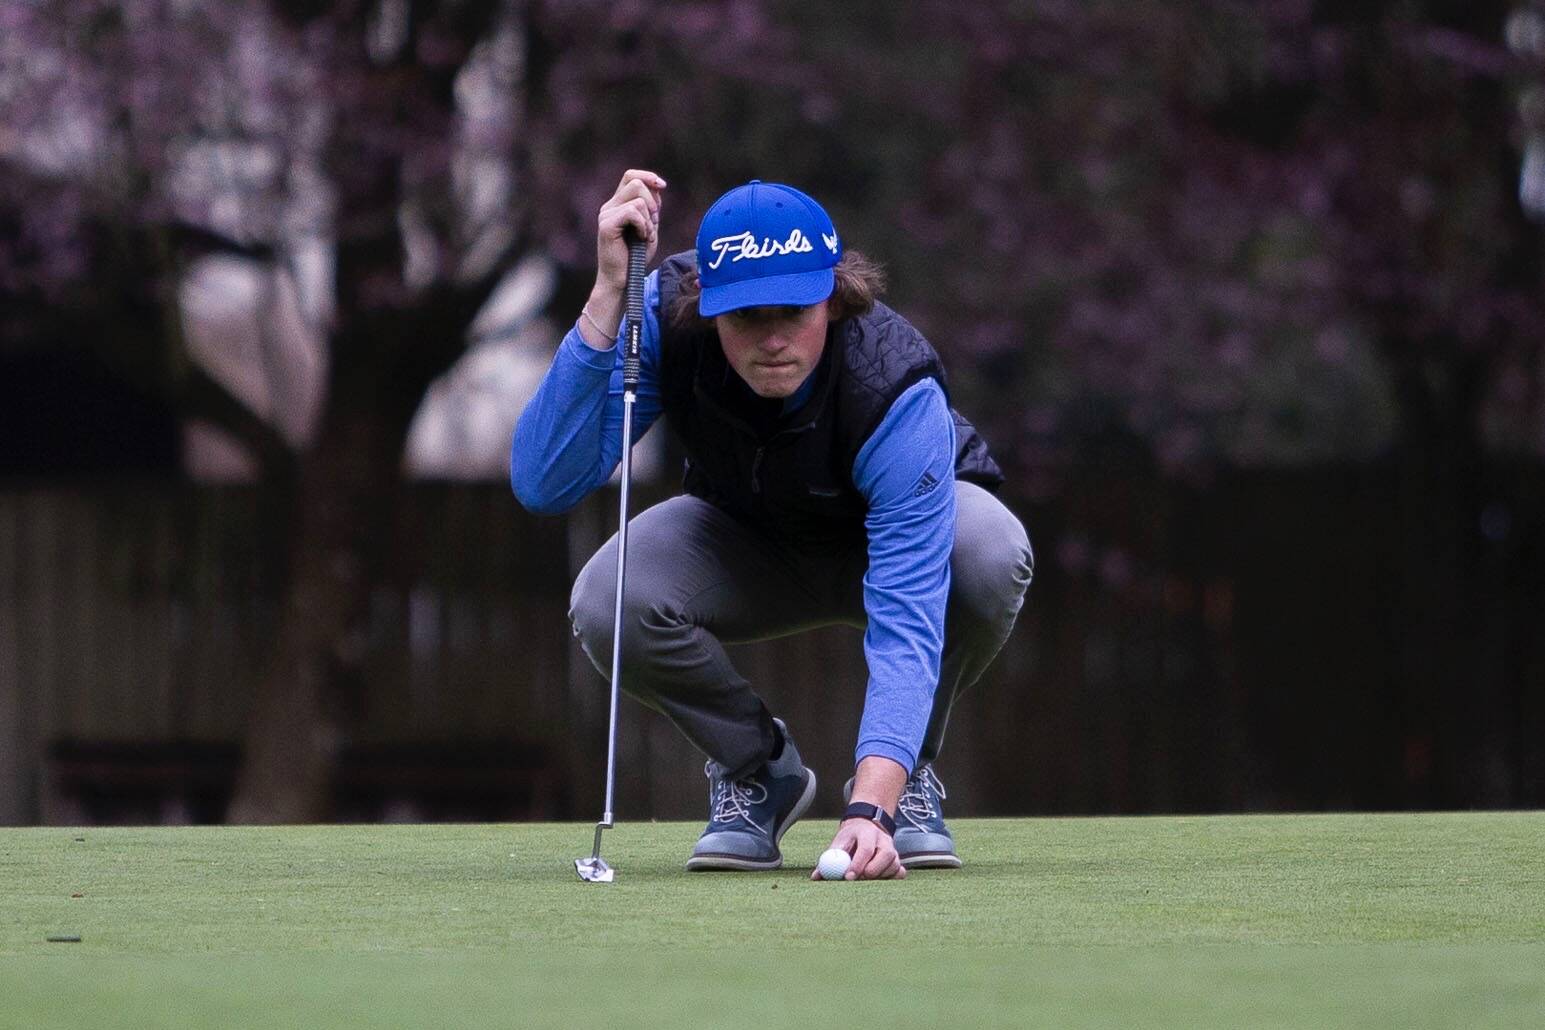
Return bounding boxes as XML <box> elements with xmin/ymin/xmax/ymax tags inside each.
<box><xmin>569</xmin><ymin>482</ymin><xmax>1035</xmax><ymax>778</ymax></box>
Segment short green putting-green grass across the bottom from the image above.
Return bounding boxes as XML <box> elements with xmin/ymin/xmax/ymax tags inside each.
<box><xmin>0</xmin><ymin>814</ymin><xmax>1545</xmax><ymax>1028</ymax></box>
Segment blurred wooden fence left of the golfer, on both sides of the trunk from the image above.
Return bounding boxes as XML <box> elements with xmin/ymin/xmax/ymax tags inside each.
<box><xmin>0</xmin><ymin>483</ymin><xmax>570</xmax><ymax>823</ymax></box>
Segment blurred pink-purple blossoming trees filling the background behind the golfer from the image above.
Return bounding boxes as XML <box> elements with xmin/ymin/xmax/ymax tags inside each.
<box><xmin>0</xmin><ymin>0</ymin><xmax>1545</xmax><ymax>818</ymax></box>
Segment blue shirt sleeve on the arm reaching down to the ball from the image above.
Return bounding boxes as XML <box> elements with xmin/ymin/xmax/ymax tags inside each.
<box><xmin>853</xmin><ymin>380</ymin><xmax>955</xmax><ymax>772</ymax></box>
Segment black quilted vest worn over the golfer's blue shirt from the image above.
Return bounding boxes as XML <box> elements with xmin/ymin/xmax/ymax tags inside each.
<box><xmin>660</xmin><ymin>250</ymin><xmax>1003</xmax><ymax>542</ymax></box>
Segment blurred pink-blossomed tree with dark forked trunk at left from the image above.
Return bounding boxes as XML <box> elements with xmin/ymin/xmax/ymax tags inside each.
<box><xmin>0</xmin><ymin>0</ymin><xmax>815</xmax><ymax>822</ymax></box>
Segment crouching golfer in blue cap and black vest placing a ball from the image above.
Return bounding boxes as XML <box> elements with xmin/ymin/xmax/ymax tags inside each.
<box><xmin>510</xmin><ymin>170</ymin><xmax>1034</xmax><ymax>879</ymax></box>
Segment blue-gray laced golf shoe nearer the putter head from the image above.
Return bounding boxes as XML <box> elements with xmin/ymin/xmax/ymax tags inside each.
<box><xmin>686</xmin><ymin>720</ymin><xmax>816</xmax><ymax>872</ymax></box>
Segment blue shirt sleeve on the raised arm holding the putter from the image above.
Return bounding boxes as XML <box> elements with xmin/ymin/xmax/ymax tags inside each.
<box><xmin>510</xmin><ymin>270</ymin><xmax>660</xmax><ymax>514</ymax></box>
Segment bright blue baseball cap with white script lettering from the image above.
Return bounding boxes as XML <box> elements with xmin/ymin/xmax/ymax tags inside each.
<box><xmin>697</xmin><ymin>179</ymin><xmax>842</xmax><ymax>318</ymax></box>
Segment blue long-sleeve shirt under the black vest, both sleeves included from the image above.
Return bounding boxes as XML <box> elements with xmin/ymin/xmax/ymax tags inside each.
<box><xmin>510</xmin><ymin>273</ymin><xmax>955</xmax><ymax>772</ymax></box>
